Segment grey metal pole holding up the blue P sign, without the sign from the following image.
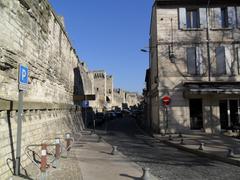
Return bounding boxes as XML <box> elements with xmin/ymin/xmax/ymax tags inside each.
<box><xmin>15</xmin><ymin>90</ymin><xmax>23</xmax><ymax>176</ymax></box>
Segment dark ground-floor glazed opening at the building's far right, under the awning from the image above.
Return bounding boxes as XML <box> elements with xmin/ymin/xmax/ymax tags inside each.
<box><xmin>219</xmin><ymin>99</ymin><xmax>240</xmax><ymax>130</ymax></box>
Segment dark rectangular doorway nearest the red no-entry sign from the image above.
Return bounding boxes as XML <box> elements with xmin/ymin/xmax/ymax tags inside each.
<box><xmin>189</xmin><ymin>99</ymin><xmax>203</xmax><ymax>130</ymax></box>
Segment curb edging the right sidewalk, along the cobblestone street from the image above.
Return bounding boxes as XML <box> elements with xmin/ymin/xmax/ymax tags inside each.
<box><xmin>159</xmin><ymin>137</ymin><xmax>240</xmax><ymax>167</ymax></box>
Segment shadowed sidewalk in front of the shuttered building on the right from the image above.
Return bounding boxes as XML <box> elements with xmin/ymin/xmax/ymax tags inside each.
<box><xmin>153</xmin><ymin>132</ymin><xmax>240</xmax><ymax>166</ymax></box>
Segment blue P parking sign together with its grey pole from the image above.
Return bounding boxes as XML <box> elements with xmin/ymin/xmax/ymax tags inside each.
<box><xmin>15</xmin><ymin>64</ymin><xmax>28</xmax><ymax>176</ymax></box>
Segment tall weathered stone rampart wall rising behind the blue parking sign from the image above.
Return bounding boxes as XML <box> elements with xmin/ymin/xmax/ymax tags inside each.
<box><xmin>0</xmin><ymin>0</ymin><xmax>86</xmax><ymax>179</ymax></box>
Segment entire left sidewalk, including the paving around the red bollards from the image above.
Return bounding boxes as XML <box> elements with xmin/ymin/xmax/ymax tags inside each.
<box><xmin>10</xmin><ymin>132</ymin><xmax>157</xmax><ymax>180</ymax></box>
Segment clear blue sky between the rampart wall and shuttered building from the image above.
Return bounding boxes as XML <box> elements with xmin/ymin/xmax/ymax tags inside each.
<box><xmin>49</xmin><ymin>0</ymin><xmax>153</xmax><ymax>93</ymax></box>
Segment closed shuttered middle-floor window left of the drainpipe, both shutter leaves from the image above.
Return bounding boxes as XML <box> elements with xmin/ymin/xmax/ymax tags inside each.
<box><xmin>187</xmin><ymin>47</ymin><xmax>203</xmax><ymax>75</ymax></box>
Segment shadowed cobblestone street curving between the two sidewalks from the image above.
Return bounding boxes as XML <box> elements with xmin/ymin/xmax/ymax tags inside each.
<box><xmin>99</xmin><ymin>119</ymin><xmax>240</xmax><ymax>180</ymax></box>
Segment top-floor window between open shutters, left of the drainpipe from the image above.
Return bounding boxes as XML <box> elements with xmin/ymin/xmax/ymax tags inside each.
<box><xmin>186</xmin><ymin>9</ymin><xmax>200</xmax><ymax>28</ymax></box>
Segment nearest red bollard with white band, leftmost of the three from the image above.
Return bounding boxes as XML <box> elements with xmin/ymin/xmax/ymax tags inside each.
<box><xmin>40</xmin><ymin>144</ymin><xmax>47</xmax><ymax>180</ymax></box>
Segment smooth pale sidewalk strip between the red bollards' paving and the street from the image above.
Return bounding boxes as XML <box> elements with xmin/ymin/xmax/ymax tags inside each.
<box><xmin>76</xmin><ymin>131</ymin><xmax>157</xmax><ymax>180</ymax></box>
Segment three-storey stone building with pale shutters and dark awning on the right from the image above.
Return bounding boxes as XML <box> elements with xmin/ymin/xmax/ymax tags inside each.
<box><xmin>144</xmin><ymin>0</ymin><xmax>240</xmax><ymax>133</ymax></box>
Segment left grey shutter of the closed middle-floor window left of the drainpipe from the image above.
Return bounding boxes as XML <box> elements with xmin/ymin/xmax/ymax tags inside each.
<box><xmin>187</xmin><ymin>47</ymin><xmax>196</xmax><ymax>74</ymax></box>
